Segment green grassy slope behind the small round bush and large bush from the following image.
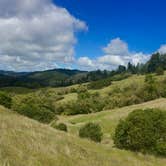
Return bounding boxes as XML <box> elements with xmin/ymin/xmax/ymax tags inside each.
<box><xmin>59</xmin><ymin>98</ymin><xmax>166</xmax><ymax>146</ymax></box>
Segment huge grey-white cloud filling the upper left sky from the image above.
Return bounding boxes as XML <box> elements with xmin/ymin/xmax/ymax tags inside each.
<box><xmin>0</xmin><ymin>0</ymin><xmax>87</xmax><ymax>71</ymax></box>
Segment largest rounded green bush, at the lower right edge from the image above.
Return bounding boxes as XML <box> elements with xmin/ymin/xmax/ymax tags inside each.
<box><xmin>114</xmin><ymin>109</ymin><xmax>166</xmax><ymax>156</ymax></box>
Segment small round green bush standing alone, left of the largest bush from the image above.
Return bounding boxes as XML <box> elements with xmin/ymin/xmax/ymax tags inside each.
<box><xmin>79</xmin><ymin>123</ymin><xmax>103</xmax><ymax>142</ymax></box>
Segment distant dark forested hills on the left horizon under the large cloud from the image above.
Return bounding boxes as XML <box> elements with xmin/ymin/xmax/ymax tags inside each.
<box><xmin>0</xmin><ymin>69</ymin><xmax>87</xmax><ymax>88</ymax></box>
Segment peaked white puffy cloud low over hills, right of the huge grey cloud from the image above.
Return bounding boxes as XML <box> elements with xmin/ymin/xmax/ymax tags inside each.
<box><xmin>78</xmin><ymin>38</ymin><xmax>150</xmax><ymax>70</ymax></box>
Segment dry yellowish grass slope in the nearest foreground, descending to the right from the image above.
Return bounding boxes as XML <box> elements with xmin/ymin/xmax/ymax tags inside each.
<box><xmin>0</xmin><ymin>104</ymin><xmax>166</xmax><ymax>166</ymax></box>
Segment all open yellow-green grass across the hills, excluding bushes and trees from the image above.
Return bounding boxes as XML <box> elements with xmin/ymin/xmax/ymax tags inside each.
<box><xmin>0</xmin><ymin>75</ymin><xmax>166</xmax><ymax>166</ymax></box>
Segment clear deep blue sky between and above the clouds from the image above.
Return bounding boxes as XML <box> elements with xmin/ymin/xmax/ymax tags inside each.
<box><xmin>54</xmin><ymin>0</ymin><xmax>166</xmax><ymax>57</ymax></box>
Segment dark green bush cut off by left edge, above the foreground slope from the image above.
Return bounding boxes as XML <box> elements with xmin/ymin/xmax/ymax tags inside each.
<box><xmin>0</xmin><ymin>92</ymin><xmax>12</xmax><ymax>108</ymax></box>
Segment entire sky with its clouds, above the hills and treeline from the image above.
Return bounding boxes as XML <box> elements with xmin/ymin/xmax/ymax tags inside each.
<box><xmin>0</xmin><ymin>0</ymin><xmax>166</xmax><ymax>71</ymax></box>
